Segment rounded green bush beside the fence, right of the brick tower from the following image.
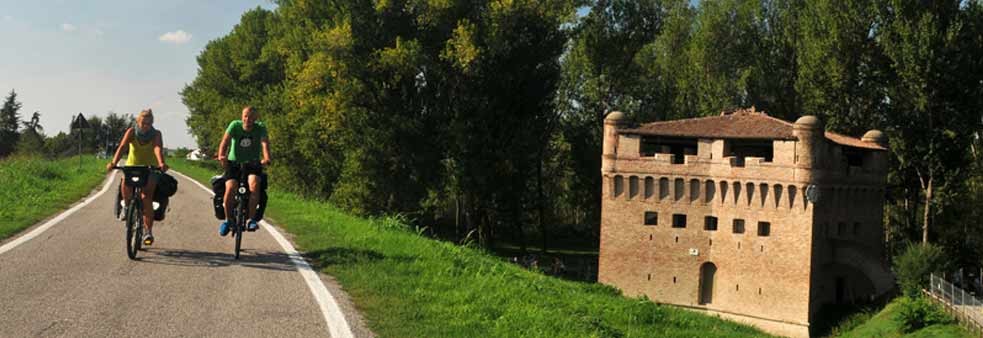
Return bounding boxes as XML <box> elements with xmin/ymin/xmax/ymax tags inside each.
<box><xmin>894</xmin><ymin>244</ymin><xmax>946</xmax><ymax>297</ymax></box>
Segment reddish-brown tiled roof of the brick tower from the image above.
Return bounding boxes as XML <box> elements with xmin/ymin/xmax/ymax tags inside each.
<box><xmin>621</xmin><ymin>107</ymin><xmax>887</xmax><ymax>150</ymax></box>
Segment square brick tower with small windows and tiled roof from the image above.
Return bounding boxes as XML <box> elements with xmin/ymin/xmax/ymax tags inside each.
<box><xmin>598</xmin><ymin>108</ymin><xmax>894</xmax><ymax>336</ymax></box>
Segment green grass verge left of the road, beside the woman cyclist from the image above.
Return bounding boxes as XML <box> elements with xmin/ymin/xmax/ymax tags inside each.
<box><xmin>0</xmin><ymin>156</ymin><xmax>106</xmax><ymax>240</ymax></box>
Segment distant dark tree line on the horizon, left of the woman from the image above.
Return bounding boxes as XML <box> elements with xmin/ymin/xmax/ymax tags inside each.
<box><xmin>0</xmin><ymin>90</ymin><xmax>133</xmax><ymax>159</ymax></box>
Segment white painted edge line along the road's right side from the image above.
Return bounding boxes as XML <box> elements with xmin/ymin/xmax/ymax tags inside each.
<box><xmin>171</xmin><ymin>169</ymin><xmax>355</xmax><ymax>338</ymax></box>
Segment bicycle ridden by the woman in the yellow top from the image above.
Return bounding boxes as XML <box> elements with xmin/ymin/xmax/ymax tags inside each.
<box><xmin>113</xmin><ymin>166</ymin><xmax>160</xmax><ymax>259</ymax></box>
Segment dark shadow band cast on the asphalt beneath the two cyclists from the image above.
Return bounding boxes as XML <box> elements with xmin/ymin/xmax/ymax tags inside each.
<box><xmin>137</xmin><ymin>248</ymin><xmax>297</xmax><ymax>271</ymax></box>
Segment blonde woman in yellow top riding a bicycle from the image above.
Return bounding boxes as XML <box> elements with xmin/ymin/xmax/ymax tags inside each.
<box><xmin>106</xmin><ymin>108</ymin><xmax>167</xmax><ymax>245</ymax></box>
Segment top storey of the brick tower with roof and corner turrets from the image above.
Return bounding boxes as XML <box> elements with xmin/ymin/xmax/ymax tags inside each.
<box><xmin>602</xmin><ymin>111</ymin><xmax>887</xmax><ymax>184</ymax></box>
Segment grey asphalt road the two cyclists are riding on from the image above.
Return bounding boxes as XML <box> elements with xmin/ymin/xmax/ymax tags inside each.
<box><xmin>0</xmin><ymin>173</ymin><xmax>371</xmax><ymax>337</ymax></box>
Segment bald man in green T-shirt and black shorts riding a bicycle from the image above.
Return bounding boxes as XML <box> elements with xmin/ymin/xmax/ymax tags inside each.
<box><xmin>218</xmin><ymin>106</ymin><xmax>270</xmax><ymax>236</ymax></box>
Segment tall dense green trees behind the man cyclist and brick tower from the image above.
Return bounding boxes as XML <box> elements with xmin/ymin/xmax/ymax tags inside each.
<box><xmin>181</xmin><ymin>0</ymin><xmax>983</xmax><ymax>263</ymax></box>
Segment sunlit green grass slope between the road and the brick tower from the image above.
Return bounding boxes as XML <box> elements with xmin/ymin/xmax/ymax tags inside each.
<box><xmin>170</xmin><ymin>160</ymin><xmax>766</xmax><ymax>337</ymax></box>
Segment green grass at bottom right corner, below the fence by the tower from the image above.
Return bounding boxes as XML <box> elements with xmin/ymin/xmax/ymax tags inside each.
<box><xmin>834</xmin><ymin>298</ymin><xmax>976</xmax><ymax>338</ymax></box>
